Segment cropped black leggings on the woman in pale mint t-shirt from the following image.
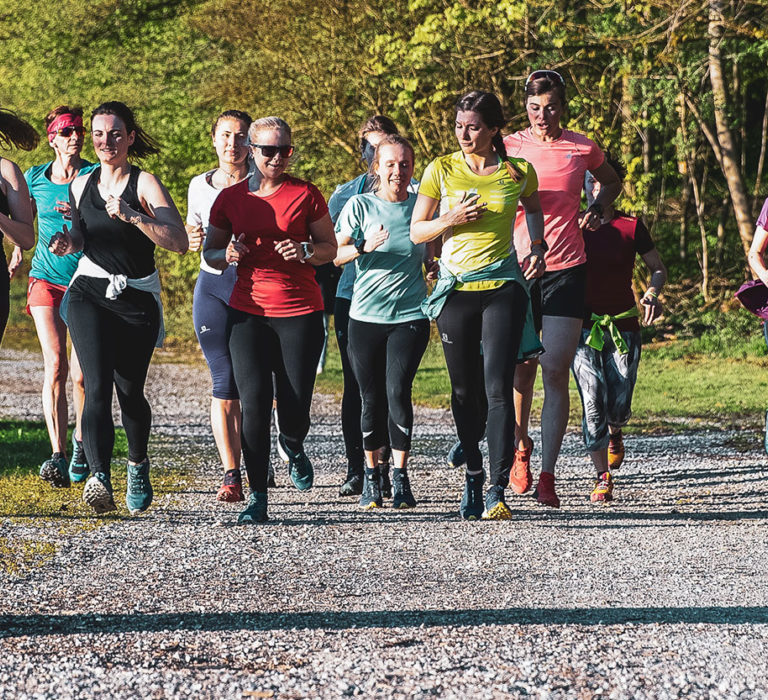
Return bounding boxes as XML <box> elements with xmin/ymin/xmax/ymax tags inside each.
<box><xmin>349</xmin><ymin>319</ymin><xmax>429</xmax><ymax>452</ymax></box>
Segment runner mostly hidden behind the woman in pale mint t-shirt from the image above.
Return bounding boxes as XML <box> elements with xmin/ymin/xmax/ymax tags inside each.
<box><xmin>328</xmin><ymin>115</ymin><xmax>404</xmax><ymax>498</ymax></box>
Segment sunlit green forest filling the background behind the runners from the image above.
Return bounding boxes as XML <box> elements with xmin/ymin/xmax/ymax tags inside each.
<box><xmin>0</xmin><ymin>0</ymin><xmax>768</xmax><ymax>372</ymax></box>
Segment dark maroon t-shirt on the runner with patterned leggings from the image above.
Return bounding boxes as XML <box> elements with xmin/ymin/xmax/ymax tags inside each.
<box><xmin>584</xmin><ymin>212</ymin><xmax>655</xmax><ymax>331</ymax></box>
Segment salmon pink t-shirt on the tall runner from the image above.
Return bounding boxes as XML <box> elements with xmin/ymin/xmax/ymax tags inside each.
<box><xmin>504</xmin><ymin>127</ymin><xmax>605</xmax><ymax>272</ymax></box>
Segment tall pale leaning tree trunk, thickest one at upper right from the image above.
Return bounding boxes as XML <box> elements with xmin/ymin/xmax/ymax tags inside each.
<box><xmin>708</xmin><ymin>0</ymin><xmax>754</xmax><ymax>255</ymax></box>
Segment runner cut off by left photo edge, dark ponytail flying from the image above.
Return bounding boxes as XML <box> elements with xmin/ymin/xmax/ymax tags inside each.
<box><xmin>0</xmin><ymin>108</ymin><xmax>39</xmax><ymax>342</ymax></box>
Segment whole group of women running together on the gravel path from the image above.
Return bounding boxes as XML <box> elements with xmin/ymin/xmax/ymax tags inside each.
<box><xmin>0</xmin><ymin>70</ymin><xmax>704</xmax><ymax>523</ymax></box>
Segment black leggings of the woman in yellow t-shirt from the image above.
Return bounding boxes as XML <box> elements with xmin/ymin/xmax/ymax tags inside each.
<box><xmin>437</xmin><ymin>282</ymin><xmax>528</xmax><ymax>487</ymax></box>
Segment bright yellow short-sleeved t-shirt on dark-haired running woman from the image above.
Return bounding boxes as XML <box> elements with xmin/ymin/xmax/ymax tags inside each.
<box><xmin>419</xmin><ymin>151</ymin><xmax>539</xmax><ymax>291</ymax></box>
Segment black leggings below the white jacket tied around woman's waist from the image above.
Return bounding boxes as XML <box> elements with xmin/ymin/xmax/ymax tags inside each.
<box><xmin>67</xmin><ymin>284</ymin><xmax>160</xmax><ymax>474</ymax></box>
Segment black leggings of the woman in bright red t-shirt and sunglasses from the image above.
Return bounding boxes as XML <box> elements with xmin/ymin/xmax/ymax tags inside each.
<box><xmin>229</xmin><ymin>309</ymin><xmax>325</xmax><ymax>493</ymax></box>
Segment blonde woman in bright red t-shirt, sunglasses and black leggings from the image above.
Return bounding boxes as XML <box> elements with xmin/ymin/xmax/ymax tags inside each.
<box><xmin>204</xmin><ymin>117</ymin><xmax>336</xmax><ymax>524</ymax></box>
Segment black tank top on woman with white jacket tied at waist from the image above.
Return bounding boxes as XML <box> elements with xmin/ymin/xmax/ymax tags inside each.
<box><xmin>79</xmin><ymin>165</ymin><xmax>155</xmax><ymax>277</ymax></box>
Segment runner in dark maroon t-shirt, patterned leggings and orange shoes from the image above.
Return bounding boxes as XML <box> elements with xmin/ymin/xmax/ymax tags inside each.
<box><xmin>573</xmin><ymin>159</ymin><xmax>667</xmax><ymax>502</ymax></box>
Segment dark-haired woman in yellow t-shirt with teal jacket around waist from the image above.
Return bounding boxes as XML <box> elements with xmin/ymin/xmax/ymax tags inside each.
<box><xmin>411</xmin><ymin>91</ymin><xmax>544</xmax><ymax>520</ymax></box>
